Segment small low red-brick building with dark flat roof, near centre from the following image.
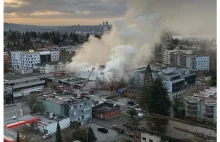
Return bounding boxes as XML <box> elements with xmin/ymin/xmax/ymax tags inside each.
<box><xmin>92</xmin><ymin>102</ymin><xmax>121</xmax><ymax>120</ymax></box>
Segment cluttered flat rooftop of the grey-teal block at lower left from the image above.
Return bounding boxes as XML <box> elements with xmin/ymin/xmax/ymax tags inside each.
<box><xmin>42</xmin><ymin>91</ymin><xmax>90</xmax><ymax>104</ymax></box>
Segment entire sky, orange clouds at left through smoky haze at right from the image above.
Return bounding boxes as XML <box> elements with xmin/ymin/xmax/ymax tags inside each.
<box><xmin>4</xmin><ymin>0</ymin><xmax>216</xmax><ymax>34</ymax></box>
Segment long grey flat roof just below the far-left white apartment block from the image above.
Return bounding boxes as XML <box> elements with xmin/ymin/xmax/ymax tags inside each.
<box><xmin>4</xmin><ymin>73</ymin><xmax>42</xmax><ymax>80</ymax></box>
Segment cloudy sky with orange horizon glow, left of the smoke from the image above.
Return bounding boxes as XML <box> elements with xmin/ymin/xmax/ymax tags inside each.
<box><xmin>4</xmin><ymin>0</ymin><xmax>128</xmax><ymax>26</ymax></box>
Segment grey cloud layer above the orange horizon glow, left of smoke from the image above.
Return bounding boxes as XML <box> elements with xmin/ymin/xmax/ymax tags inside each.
<box><xmin>4</xmin><ymin>0</ymin><xmax>126</xmax><ymax>18</ymax></box>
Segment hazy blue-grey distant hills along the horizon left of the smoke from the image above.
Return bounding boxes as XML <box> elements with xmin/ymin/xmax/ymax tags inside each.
<box><xmin>4</xmin><ymin>23</ymin><xmax>110</xmax><ymax>33</ymax></box>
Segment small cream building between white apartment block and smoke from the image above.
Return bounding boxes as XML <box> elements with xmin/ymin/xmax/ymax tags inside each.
<box><xmin>36</xmin><ymin>61</ymin><xmax>65</xmax><ymax>74</ymax></box>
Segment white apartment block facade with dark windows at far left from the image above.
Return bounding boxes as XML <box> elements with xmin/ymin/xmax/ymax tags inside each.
<box><xmin>11</xmin><ymin>51</ymin><xmax>40</xmax><ymax>70</ymax></box>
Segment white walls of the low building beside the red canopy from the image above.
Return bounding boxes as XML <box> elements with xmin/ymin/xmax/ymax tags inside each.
<box><xmin>37</xmin><ymin>118</ymin><xmax>70</xmax><ymax>134</ymax></box>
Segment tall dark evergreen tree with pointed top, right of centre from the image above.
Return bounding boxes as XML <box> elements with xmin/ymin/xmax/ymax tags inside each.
<box><xmin>145</xmin><ymin>79</ymin><xmax>171</xmax><ymax>116</ymax></box>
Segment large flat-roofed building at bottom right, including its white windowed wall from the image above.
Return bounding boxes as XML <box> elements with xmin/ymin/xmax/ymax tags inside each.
<box><xmin>124</xmin><ymin>114</ymin><xmax>217</xmax><ymax>142</ymax></box>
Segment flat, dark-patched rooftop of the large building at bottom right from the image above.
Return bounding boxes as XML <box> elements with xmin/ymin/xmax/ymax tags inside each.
<box><xmin>125</xmin><ymin>114</ymin><xmax>217</xmax><ymax>142</ymax></box>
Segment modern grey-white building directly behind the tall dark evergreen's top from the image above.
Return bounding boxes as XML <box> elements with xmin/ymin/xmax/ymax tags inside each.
<box><xmin>134</xmin><ymin>66</ymin><xmax>196</xmax><ymax>101</ymax></box>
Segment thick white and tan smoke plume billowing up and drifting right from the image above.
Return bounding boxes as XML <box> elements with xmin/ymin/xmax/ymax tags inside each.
<box><xmin>66</xmin><ymin>0</ymin><xmax>216</xmax><ymax>81</ymax></box>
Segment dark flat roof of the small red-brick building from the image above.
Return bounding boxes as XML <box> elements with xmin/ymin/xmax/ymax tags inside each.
<box><xmin>92</xmin><ymin>102</ymin><xmax>120</xmax><ymax>113</ymax></box>
